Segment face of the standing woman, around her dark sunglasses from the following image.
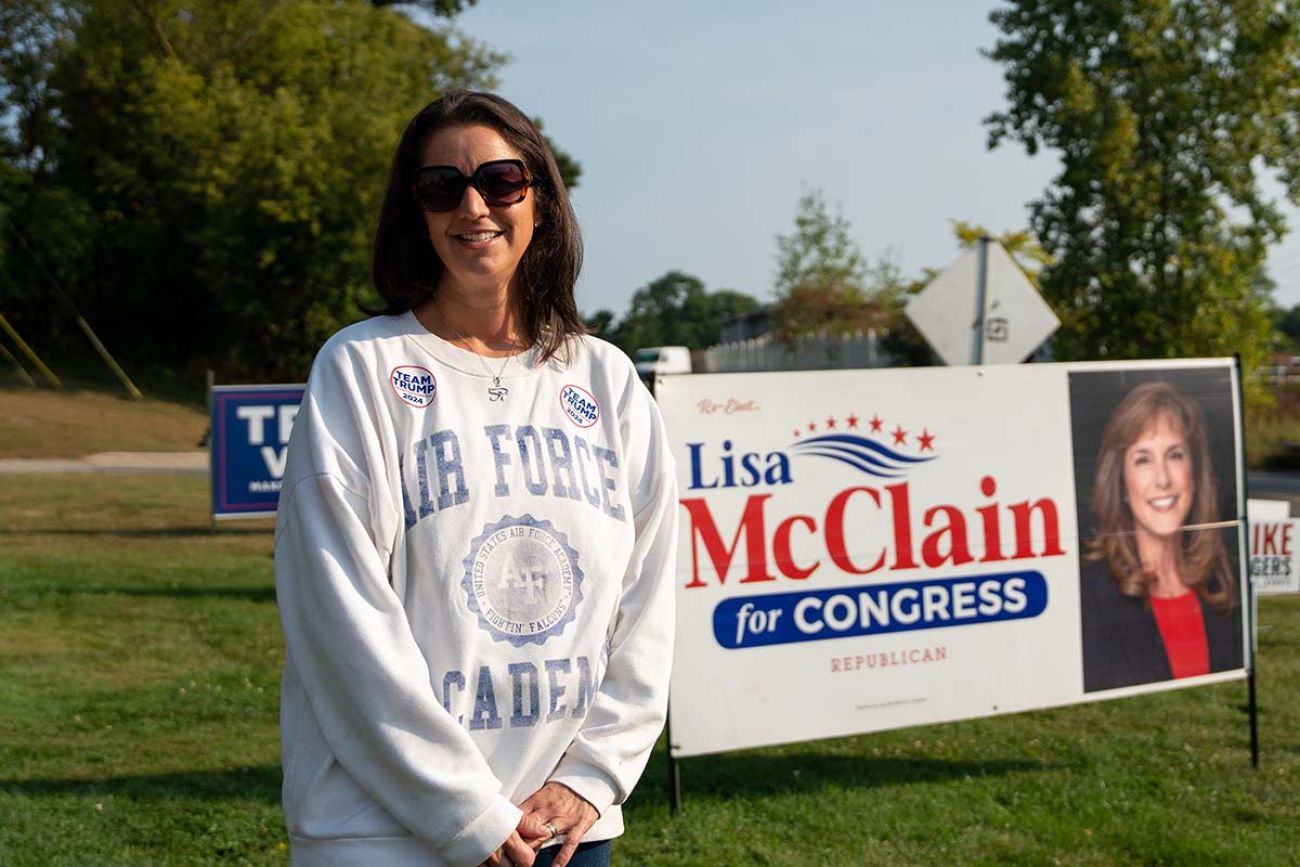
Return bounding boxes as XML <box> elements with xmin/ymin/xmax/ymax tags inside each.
<box><xmin>420</xmin><ymin>126</ymin><xmax>536</xmax><ymax>301</ymax></box>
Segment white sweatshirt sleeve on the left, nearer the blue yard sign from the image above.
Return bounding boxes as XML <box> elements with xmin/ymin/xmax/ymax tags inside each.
<box><xmin>276</xmin><ymin>343</ymin><xmax>521</xmax><ymax>864</ymax></box>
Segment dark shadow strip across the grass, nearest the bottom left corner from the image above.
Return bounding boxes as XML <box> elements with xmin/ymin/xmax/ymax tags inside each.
<box><xmin>0</xmin><ymin>764</ymin><xmax>281</xmax><ymax>802</ymax></box>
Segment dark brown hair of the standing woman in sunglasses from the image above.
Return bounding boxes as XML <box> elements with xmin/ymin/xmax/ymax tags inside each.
<box><xmin>367</xmin><ymin>91</ymin><xmax>586</xmax><ymax>359</ymax></box>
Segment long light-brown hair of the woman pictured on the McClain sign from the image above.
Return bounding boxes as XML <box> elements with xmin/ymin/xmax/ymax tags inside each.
<box><xmin>1086</xmin><ymin>382</ymin><xmax>1236</xmax><ymax>612</ymax></box>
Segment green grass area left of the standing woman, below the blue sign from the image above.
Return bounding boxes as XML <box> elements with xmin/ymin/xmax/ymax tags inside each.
<box><xmin>0</xmin><ymin>476</ymin><xmax>285</xmax><ymax>864</ymax></box>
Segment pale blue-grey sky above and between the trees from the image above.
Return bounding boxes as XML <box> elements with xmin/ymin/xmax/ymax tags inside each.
<box><xmin>444</xmin><ymin>0</ymin><xmax>1300</xmax><ymax>316</ymax></box>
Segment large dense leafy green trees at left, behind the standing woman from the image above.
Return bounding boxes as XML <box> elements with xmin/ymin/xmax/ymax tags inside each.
<box><xmin>0</xmin><ymin>0</ymin><xmax>577</xmax><ymax>380</ymax></box>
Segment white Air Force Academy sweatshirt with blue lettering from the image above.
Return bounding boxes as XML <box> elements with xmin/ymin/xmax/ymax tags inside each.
<box><xmin>276</xmin><ymin>313</ymin><xmax>677</xmax><ymax>866</ymax></box>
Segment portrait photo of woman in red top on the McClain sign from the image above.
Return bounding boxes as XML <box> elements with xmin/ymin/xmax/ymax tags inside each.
<box><xmin>1070</xmin><ymin>367</ymin><xmax>1245</xmax><ymax>693</ymax></box>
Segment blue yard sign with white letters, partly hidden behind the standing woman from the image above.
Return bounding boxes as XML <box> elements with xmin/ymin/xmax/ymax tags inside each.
<box><xmin>209</xmin><ymin>385</ymin><xmax>306</xmax><ymax>519</ymax></box>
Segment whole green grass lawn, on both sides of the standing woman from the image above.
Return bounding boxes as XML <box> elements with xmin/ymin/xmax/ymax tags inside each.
<box><xmin>0</xmin><ymin>476</ymin><xmax>1300</xmax><ymax>867</ymax></box>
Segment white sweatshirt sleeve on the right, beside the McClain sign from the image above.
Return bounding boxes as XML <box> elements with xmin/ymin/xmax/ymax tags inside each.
<box><xmin>551</xmin><ymin>369</ymin><xmax>677</xmax><ymax>814</ymax></box>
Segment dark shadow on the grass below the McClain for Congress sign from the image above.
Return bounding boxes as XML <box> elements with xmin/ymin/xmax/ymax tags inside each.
<box><xmin>633</xmin><ymin>753</ymin><xmax>1066</xmax><ymax>809</ymax></box>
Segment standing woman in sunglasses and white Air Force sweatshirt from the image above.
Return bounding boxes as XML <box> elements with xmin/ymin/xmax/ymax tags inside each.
<box><xmin>276</xmin><ymin>92</ymin><xmax>676</xmax><ymax>867</ymax></box>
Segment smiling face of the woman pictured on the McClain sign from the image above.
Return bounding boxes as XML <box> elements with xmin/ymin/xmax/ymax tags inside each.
<box><xmin>1125</xmin><ymin>415</ymin><xmax>1195</xmax><ymax>537</ymax></box>
